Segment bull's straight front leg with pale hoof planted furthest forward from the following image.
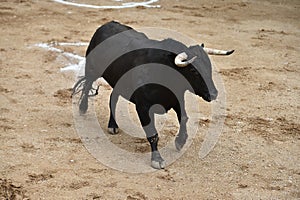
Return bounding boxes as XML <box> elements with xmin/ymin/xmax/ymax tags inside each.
<box><xmin>136</xmin><ymin>105</ymin><xmax>166</xmax><ymax>169</ymax></box>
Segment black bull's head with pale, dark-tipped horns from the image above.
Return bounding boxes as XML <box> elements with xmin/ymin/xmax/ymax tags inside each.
<box><xmin>174</xmin><ymin>45</ymin><xmax>234</xmax><ymax>102</ymax></box>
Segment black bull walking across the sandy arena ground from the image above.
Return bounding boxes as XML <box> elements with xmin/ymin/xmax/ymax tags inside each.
<box><xmin>73</xmin><ymin>22</ymin><xmax>234</xmax><ymax>169</ymax></box>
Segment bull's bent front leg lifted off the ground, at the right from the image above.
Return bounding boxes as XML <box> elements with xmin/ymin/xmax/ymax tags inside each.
<box><xmin>174</xmin><ymin>104</ymin><xmax>188</xmax><ymax>151</ymax></box>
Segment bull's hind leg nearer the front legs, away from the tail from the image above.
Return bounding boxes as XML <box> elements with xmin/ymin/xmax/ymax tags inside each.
<box><xmin>108</xmin><ymin>92</ymin><xmax>119</xmax><ymax>134</ymax></box>
